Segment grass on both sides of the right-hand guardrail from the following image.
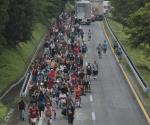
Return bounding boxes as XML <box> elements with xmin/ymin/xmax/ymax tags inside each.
<box><xmin>106</xmin><ymin>19</ymin><xmax>150</xmax><ymax>108</ymax></box>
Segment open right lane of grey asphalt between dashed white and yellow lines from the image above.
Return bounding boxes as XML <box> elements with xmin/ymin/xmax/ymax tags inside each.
<box><xmin>80</xmin><ymin>22</ymin><xmax>147</xmax><ymax>125</ymax></box>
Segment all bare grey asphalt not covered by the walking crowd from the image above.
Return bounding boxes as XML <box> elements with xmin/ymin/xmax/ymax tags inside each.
<box><xmin>6</xmin><ymin>22</ymin><xmax>148</xmax><ymax>125</ymax></box>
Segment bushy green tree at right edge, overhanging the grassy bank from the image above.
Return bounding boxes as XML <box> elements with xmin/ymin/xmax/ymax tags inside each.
<box><xmin>128</xmin><ymin>2</ymin><xmax>150</xmax><ymax>46</ymax></box>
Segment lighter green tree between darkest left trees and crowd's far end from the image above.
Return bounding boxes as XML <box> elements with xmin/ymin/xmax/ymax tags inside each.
<box><xmin>33</xmin><ymin>0</ymin><xmax>65</xmax><ymax>24</ymax></box>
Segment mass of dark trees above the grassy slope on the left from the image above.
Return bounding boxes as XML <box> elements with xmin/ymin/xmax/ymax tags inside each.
<box><xmin>0</xmin><ymin>0</ymin><xmax>68</xmax><ymax>47</ymax></box>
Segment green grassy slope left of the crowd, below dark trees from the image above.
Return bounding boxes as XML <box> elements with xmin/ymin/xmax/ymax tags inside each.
<box><xmin>0</xmin><ymin>23</ymin><xmax>46</xmax><ymax>93</ymax></box>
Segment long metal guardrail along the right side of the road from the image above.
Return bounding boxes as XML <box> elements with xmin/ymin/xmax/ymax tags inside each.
<box><xmin>105</xmin><ymin>17</ymin><xmax>150</xmax><ymax>94</ymax></box>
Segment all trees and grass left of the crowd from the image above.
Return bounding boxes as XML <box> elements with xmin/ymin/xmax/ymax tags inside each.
<box><xmin>0</xmin><ymin>0</ymin><xmax>73</xmax><ymax>123</ymax></box>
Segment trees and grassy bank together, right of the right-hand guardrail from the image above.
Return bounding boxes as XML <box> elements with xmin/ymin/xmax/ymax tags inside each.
<box><xmin>109</xmin><ymin>0</ymin><xmax>150</xmax><ymax>86</ymax></box>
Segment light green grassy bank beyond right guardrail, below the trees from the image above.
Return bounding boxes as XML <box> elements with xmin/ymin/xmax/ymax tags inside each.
<box><xmin>106</xmin><ymin>19</ymin><xmax>150</xmax><ymax>86</ymax></box>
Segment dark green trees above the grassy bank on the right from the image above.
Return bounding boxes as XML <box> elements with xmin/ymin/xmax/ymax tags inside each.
<box><xmin>110</xmin><ymin>0</ymin><xmax>150</xmax><ymax>47</ymax></box>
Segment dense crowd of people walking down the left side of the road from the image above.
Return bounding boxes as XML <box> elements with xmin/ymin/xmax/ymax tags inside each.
<box><xmin>18</xmin><ymin>12</ymin><xmax>98</xmax><ymax>125</ymax></box>
